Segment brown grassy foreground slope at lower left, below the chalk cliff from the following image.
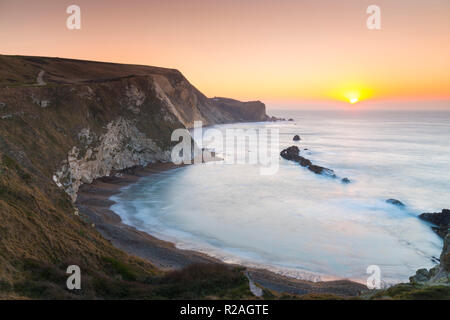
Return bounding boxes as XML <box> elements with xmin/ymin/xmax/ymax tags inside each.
<box><xmin>0</xmin><ymin>154</ymin><xmax>252</xmax><ymax>299</ymax></box>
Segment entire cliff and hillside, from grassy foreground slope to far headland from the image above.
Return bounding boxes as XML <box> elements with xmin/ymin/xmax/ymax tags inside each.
<box><xmin>0</xmin><ymin>55</ymin><xmax>267</xmax><ymax>298</ymax></box>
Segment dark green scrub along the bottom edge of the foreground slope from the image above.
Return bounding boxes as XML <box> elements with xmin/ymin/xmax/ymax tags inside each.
<box><xmin>7</xmin><ymin>258</ymin><xmax>252</xmax><ymax>299</ymax></box>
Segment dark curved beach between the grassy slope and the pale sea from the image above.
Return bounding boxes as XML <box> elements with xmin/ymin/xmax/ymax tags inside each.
<box><xmin>76</xmin><ymin>163</ymin><xmax>367</xmax><ymax>296</ymax></box>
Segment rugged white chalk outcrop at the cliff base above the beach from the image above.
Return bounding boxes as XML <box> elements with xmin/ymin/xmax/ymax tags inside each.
<box><xmin>53</xmin><ymin>118</ymin><xmax>170</xmax><ymax>201</ymax></box>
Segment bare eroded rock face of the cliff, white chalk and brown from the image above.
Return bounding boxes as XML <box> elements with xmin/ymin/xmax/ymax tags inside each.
<box><xmin>48</xmin><ymin>75</ymin><xmax>265</xmax><ymax>201</ymax></box>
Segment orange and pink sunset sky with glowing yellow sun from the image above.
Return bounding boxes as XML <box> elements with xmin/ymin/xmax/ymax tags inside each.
<box><xmin>0</xmin><ymin>0</ymin><xmax>450</xmax><ymax>109</ymax></box>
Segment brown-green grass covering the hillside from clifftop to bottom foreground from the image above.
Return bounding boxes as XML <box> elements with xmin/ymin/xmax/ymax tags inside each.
<box><xmin>0</xmin><ymin>56</ymin><xmax>252</xmax><ymax>299</ymax></box>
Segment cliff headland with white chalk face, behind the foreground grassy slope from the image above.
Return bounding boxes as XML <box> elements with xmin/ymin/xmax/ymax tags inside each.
<box><xmin>0</xmin><ymin>56</ymin><xmax>269</xmax><ymax>201</ymax></box>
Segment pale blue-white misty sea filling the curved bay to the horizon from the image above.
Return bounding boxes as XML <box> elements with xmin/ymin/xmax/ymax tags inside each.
<box><xmin>111</xmin><ymin>110</ymin><xmax>450</xmax><ymax>285</ymax></box>
